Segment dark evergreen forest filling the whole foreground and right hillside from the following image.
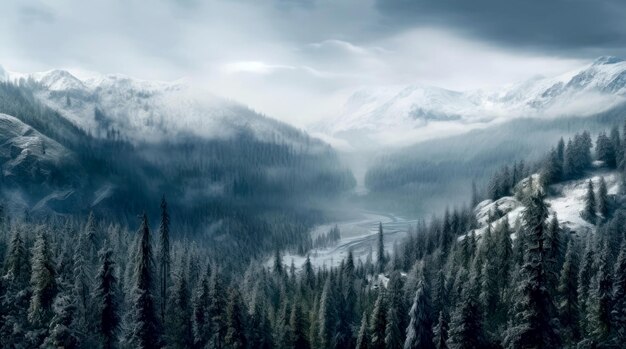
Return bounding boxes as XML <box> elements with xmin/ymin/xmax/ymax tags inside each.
<box><xmin>0</xmin><ymin>121</ymin><xmax>626</xmax><ymax>349</ymax></box>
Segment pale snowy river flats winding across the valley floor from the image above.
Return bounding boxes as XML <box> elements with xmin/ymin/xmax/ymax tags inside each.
<box><xmin>276</xmin><ymin>212</ymin><xmax>416</xmax><ymax>269</ymax></box>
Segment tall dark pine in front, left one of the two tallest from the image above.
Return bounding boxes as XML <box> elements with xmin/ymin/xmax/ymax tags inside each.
<box><xmin>129</xmin><ymin>213</ymin><xmax>161</xmax><ymax>349</ymax></box>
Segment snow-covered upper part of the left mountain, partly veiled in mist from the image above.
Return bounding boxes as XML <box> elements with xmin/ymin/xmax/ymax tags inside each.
<box><xmin>0</xmin><ymin>68</ymin><xmax>322</xmax><ymax>151</ymax></box>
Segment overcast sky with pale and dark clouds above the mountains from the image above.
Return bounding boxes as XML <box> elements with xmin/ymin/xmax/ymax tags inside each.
<box><xmin>0</xmin><ymin>0</ymin><xmax>626</xmax><ymax>126</ymax></box>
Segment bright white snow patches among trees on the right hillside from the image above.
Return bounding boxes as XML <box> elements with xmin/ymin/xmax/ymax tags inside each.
<box><xmin>466</xmin><ymin>168</ymin><xmax>620</xmax><ymax>239</ymax></box>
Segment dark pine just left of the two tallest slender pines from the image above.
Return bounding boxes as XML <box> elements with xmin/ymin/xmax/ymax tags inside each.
<box><xmin>95</xmin><ymin>247</ymin><xmax>120</xmax><ymax>349</ymax></box>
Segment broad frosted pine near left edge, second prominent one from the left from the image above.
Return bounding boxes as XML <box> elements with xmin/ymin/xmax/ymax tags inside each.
<box><xmin>28</xmin><ymin>232</ymin><xmax>57</xmax><ymax>326</ymax></box>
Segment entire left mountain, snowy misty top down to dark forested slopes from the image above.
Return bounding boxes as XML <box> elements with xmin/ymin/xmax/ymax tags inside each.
<box><xmin>0</xmin><ymin>63</ymin><xmax>354</xmax><ymax>215</ymax></box>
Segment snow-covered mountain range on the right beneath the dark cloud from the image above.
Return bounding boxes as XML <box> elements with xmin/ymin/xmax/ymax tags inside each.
<box><xmin>311</xmin><ymin>57</ymin><xmax>626</xmax><ymax>145</ymax></box>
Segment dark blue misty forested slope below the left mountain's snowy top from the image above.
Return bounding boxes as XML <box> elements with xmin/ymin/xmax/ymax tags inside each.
<box><xmin>0</xmin><ymin>80</ymin><xmax>354</xmax><ymax>267</ymax></box>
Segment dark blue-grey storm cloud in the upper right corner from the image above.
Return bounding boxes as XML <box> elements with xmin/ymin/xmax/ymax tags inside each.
<box><xmin>377</xmin><ymin>0</ymin><xmax>626</xmax><ymax>56</ymax></box>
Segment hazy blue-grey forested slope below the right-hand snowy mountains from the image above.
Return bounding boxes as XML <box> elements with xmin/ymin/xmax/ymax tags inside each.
<box><xmin>363</xmin><ymin>101</ymin><xmax>626</xmax><ymax>215</ymax></box>
